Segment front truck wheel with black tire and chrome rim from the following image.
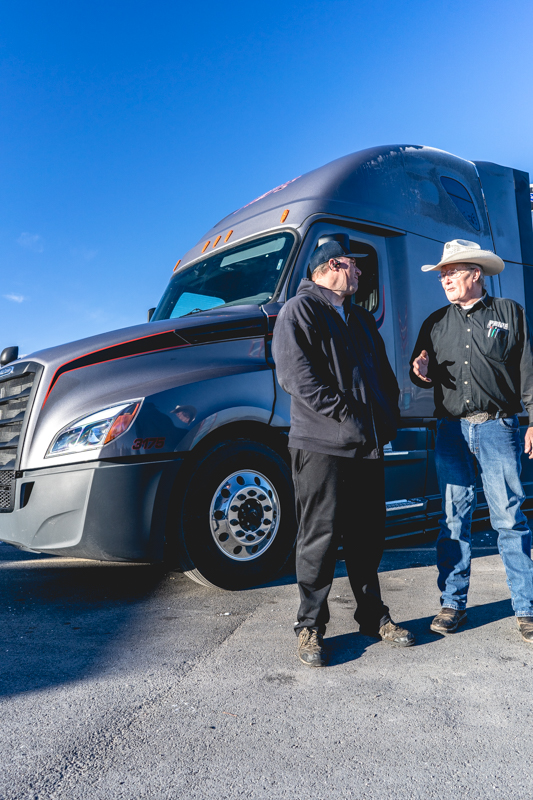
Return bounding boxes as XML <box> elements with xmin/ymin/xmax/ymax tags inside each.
<box><xmin>179</xmin><ymin>439</ymin><xmax>296</xmax><ymax>589</ymax></box>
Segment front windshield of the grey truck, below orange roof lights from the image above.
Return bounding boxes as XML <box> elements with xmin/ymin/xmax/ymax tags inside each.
<box><xmin>152</xmin><ymin>231</ymin><xmax>294</xmax><ymax>320</ymax></box>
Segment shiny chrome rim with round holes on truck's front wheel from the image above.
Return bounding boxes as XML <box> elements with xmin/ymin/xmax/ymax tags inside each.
<box><xmin>209</xmin><ymin>470</ymin><xmax>280</xmax><ymax>561</ymax></box>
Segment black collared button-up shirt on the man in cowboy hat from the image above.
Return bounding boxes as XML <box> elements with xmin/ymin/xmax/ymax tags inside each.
<box><xmin>410</xmin><ymin>294</ymin><xmax>533</xmax><ymax>425</ymax></box>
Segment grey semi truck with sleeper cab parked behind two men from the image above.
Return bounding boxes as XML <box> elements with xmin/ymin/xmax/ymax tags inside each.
<box><xmin>0</xmin><ymin>145</ymin><xmax>533</xmax><ymax>589</ymax></box>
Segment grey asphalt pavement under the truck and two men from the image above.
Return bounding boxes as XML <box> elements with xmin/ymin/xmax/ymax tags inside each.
<box><xmin>0</xmin><ymin>533</ymin><xmax>533</xmax><ymax>800</ymax></box>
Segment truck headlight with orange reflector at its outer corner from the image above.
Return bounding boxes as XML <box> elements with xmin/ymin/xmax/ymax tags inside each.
<box><xmin>46</xmin><ymin>400</ymin><xmax>142</xmax><ymax>458</ymax></box>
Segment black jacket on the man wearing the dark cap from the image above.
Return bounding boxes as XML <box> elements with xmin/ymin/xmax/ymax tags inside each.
<box><xmin>272</xmin><ymin>279</ymin><xmax>399</xmax><ymax>458</ymax></box>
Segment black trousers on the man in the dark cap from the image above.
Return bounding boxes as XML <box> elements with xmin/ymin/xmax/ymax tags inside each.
<box><xmin>291</xmin><ymin>449</ymin><xmax>390</xmax><ymax>634</ymax></box>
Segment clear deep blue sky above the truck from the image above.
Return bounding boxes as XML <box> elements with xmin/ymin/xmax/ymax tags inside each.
<box><xmin>0</xmin><ymin>0</ymin><xmax>533</xmax><ymax>353</ymax></box>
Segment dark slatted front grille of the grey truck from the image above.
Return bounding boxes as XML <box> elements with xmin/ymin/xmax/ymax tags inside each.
<box><xmin>0</xmin><ymin>372</ymin><xmax>35</xmax><ymax>511</ymax></box>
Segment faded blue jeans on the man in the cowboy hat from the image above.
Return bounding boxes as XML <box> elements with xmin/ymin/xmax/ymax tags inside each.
<box><xmin>435</xmin><ymin>417</ymin><xmax>533</xmax><ymax>617</ymax></box>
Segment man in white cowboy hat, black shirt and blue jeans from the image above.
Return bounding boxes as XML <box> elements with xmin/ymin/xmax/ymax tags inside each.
<box><xmin>411</xmin><ymin>239</ymin><xmax>533</xmax><ymax>643</ymax></box>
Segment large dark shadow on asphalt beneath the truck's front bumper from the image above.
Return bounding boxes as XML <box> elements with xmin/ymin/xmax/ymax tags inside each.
<box><xmin>0</xmin><ymin>547</ymin><xmax>165</xmax><ymax>696</ymax></box>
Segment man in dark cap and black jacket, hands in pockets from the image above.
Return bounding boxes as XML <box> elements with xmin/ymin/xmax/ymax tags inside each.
<box><xmin>272</xmin><ymin>241</ymin><xmax>414</xmax><ymax>667</ymax></box>
